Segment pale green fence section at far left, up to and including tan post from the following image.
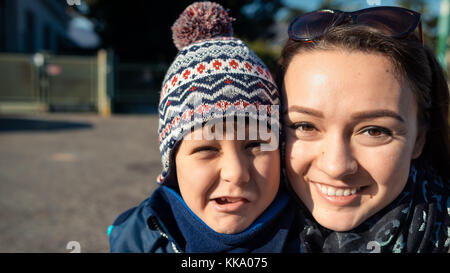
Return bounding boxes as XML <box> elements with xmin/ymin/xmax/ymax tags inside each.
<box><xmin>0</xmin><ymin>50</ymin><xmax>110</xmax><ymax>115</ymax></box>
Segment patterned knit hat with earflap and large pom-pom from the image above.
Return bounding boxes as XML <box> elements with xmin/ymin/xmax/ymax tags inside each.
<box><xmin>157</xmin><ymin>1</ymin><xmax>280</xmax><ymax>184</ymax></box>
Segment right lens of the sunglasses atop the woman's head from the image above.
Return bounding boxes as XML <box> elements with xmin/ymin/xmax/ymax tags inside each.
<box><xmin>356</xmin><ymin>9</ymin><xmax>419</xmax><ymax>37</ymax></box>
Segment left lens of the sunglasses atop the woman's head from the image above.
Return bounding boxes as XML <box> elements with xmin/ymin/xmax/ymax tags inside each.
<box><xmin>289</xmin><ymin>11</ymin><xmax>340</xmax><ymax>40</ymax></box>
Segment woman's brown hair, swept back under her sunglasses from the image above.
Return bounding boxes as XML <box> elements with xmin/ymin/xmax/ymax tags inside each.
<box><xmin>275</xmin><ymin>24</ymin><xmax>450</xmax><ymax>179</ymax></box>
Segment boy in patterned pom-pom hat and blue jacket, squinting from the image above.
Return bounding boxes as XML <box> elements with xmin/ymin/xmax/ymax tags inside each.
<box><xmin>108</xmin><ymin>2</ymin><xmax>299</xmax><ymax>253</ymax></box>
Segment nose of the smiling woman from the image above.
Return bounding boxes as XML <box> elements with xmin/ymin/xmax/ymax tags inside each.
<box><xmin>318</xmin><ymin>136</ymin><xmax>358</xmax><ymax>179</ymax></box>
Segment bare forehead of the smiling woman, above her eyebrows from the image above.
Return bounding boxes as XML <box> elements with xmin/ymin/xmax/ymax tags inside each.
<box><xmin>282</xmin><ymin>50</ymin><xmax>417</xmax><ymax>120</ymax></box>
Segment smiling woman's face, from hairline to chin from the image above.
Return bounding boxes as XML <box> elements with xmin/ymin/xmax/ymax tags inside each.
<box><xmin>283</xmin><ymin>49</ymin><xmax>424</xmax><ymax>231</ymax></box>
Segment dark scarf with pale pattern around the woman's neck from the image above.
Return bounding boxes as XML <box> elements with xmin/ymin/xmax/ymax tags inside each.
<box><xmin>297</xmin><ymin>164</ymin><xmax>450</xmax><ymax>253</ymax></box>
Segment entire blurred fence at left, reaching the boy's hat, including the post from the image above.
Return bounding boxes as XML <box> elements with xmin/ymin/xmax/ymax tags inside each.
<box><xmin>0</xmin><ymin>50</ymin><xmax>168</xmax><ymax>115</ymax></box>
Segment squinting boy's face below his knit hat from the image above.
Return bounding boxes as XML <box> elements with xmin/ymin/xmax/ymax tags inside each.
<box><xmin>175</xmin><ymin>122</ymin><xmax>280</xmax><ymax>234</ymax></box>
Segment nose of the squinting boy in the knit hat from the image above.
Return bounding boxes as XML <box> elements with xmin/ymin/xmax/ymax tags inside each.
<box><xmin>220</xmin><ymin>148</ymin><xmax>250</xmax><ymax>183</ymax></box>
